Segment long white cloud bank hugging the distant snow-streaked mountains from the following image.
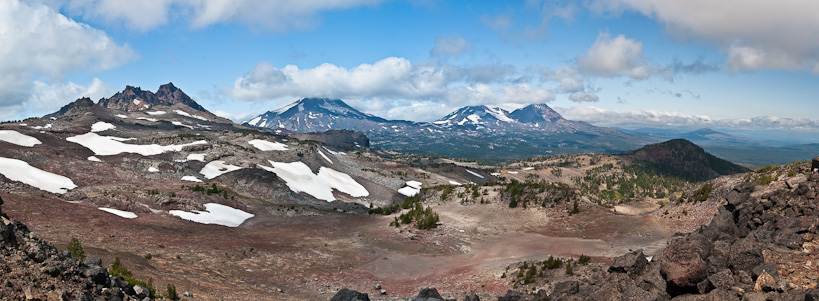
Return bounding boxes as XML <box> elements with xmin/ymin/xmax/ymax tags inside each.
<box><xmin>227</xmin><ymin>57</ymin><xmax>554</xmax><ymax>121</ymax></box>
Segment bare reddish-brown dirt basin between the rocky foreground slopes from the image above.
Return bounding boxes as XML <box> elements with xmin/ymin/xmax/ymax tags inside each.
<box><xmin>0</xmin><ymin>186</ymin><xmax>716</xmax><ymax>300</ymax></box>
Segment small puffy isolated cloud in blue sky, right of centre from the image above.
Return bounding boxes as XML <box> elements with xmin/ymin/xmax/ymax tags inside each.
<box><xmin>577</xmin><ymin>32</ymin><xmax>655</xmax><ymax>79</ymax></box>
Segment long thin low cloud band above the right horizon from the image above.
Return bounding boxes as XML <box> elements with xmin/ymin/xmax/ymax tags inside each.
<box><xmin>555</xmin><ymin>106</ymin><xmax>819</xmax><ymax>132</ymax></box>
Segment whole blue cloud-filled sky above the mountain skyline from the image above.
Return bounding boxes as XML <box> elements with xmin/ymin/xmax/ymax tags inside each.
<box><xmin>0</xmin><ymin>0</ymin><xmax>819</xmax><ymax>141</ymax></box>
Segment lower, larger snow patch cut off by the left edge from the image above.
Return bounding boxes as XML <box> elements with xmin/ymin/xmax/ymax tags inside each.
<box><xmin>0</xmin><ymin>157</ymin><xmax>77</xmax><ymax>194</ymax></box>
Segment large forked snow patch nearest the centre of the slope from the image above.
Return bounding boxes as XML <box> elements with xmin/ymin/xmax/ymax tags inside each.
<box><xmin>258</xmin><ymin>160</ymin><xmax>370</xmax><ymax>202</ymax></box>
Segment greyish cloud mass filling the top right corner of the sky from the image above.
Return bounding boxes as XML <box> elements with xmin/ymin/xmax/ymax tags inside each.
<box><xmin>590</xmin><ymin>0</ymin><xmax>819</xmax><ymax>73</ymax></box>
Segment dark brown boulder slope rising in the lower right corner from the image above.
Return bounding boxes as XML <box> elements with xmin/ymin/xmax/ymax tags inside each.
<box><xmin>331</xmin><ymin>159</ymin><xmax>819</xmax><ymax>301</ymax></box>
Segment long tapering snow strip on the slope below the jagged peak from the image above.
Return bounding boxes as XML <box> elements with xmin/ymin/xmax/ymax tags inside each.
<box><xmin>65</xmin><ymin>133</ymin><xmax>207</xmax><ymax>156</ymax></box>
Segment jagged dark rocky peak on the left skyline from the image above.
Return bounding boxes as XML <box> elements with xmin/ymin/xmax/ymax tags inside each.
<box><xmin>99</xmin><ymin>83</ymin><xmax>206</xmax><ymax>112</ymax></box>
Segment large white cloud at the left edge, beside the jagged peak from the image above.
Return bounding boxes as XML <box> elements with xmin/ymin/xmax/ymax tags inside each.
<box><xmin>0</xmin><ymin>0</ymin><xmax>136</xmax><ymax>117</ymax></box>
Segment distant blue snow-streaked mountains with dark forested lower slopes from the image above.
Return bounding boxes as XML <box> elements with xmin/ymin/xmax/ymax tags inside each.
<box><xmin>244</xmin><ymin>98</ymin><xmax>660</xmax><ymax>161</ymax></box>
